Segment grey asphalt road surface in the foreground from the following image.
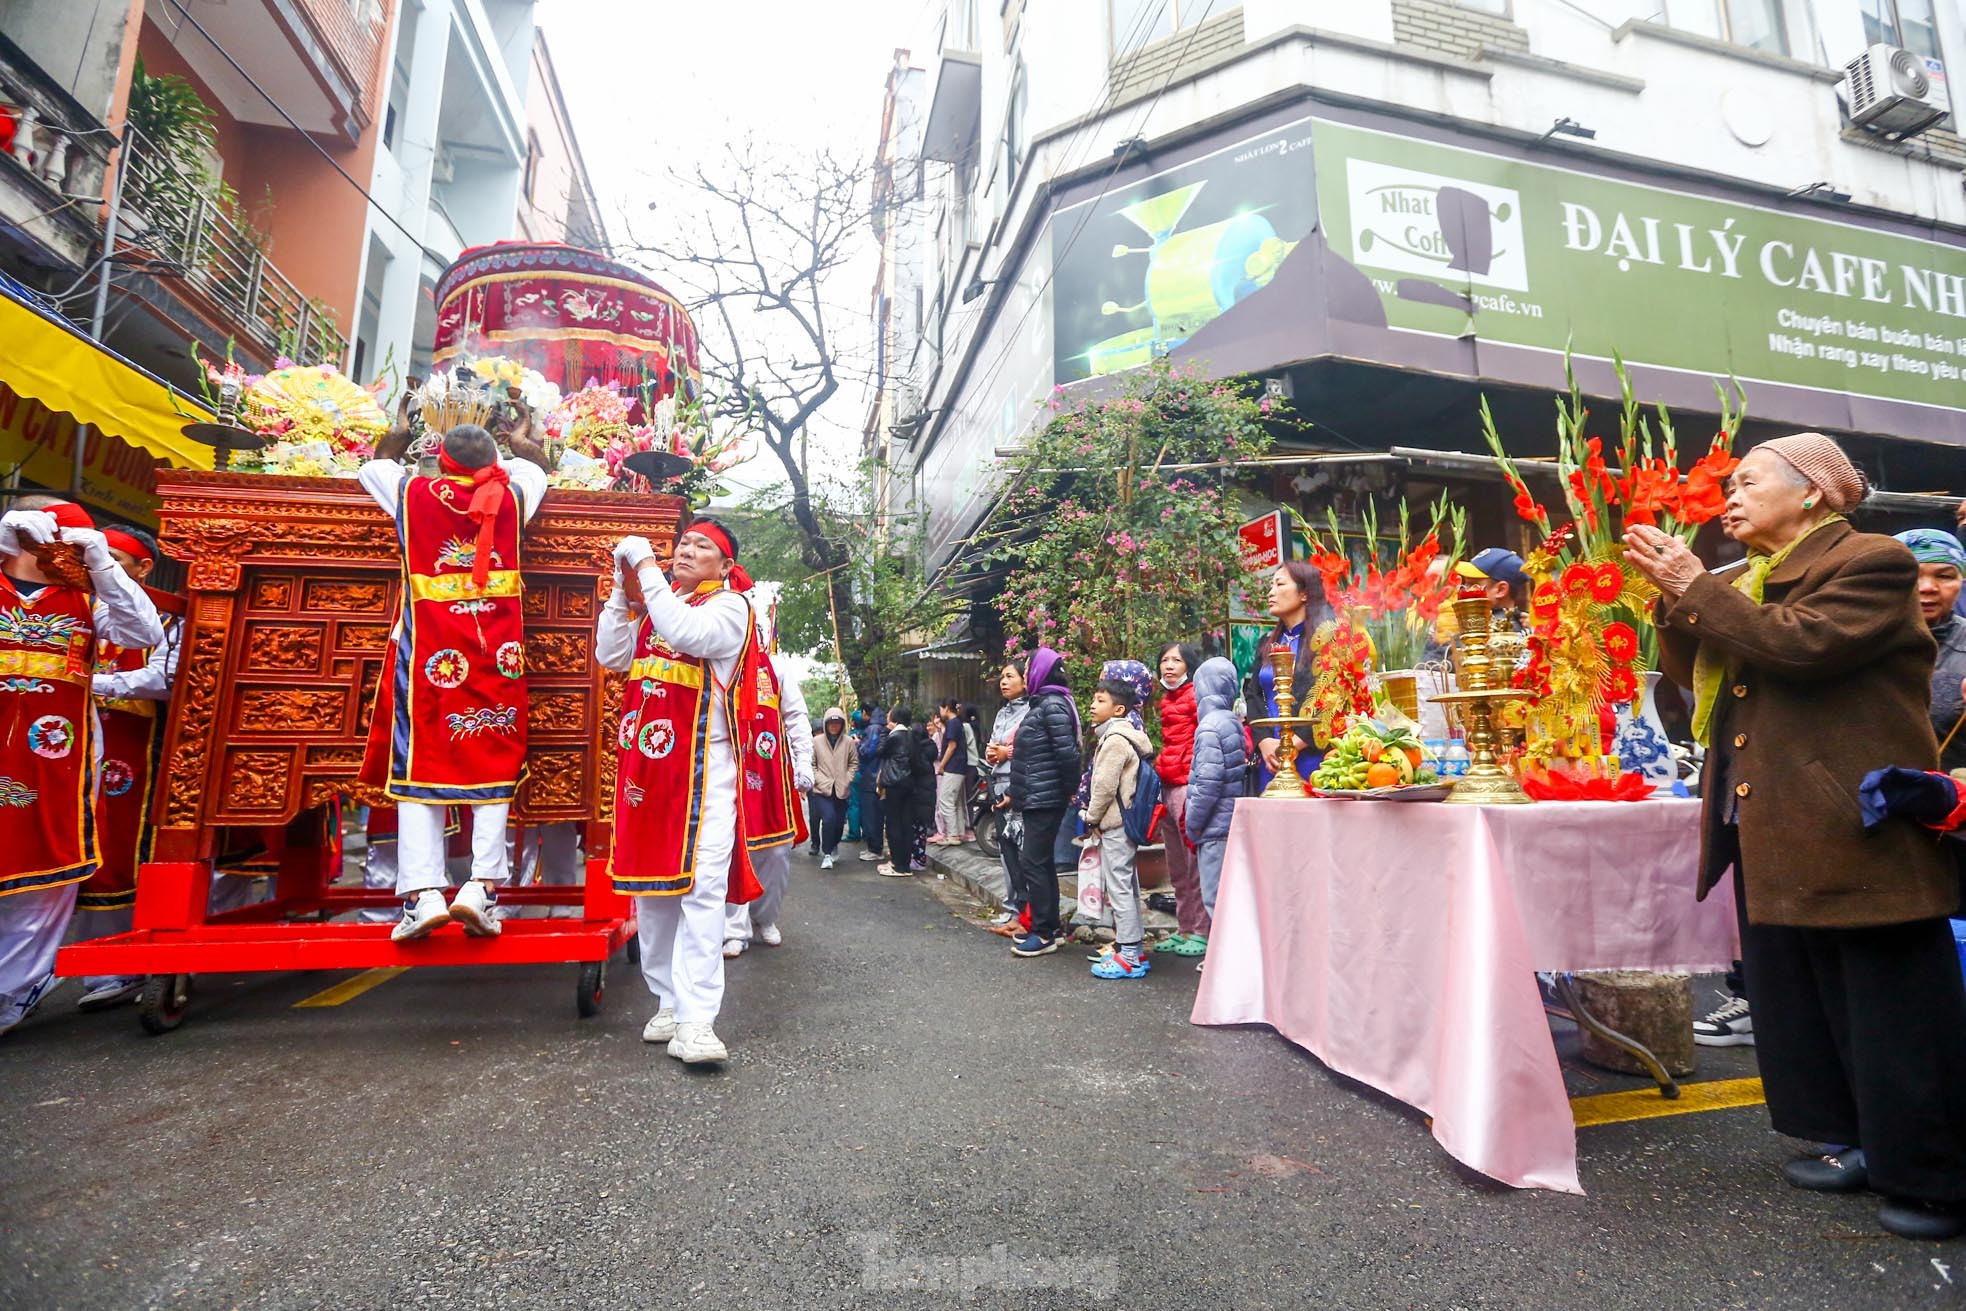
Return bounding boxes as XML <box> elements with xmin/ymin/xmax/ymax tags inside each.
<box><xmin>0</xmin><ymin>855</ymin><xmax>1966</xmax><ymax>1311</ymax></box>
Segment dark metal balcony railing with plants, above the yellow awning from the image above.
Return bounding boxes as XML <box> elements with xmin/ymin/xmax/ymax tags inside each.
<box><xmin>118</xmin><ymin>128</ymin><xmax>348</xmax><ymax>366</ymax></box>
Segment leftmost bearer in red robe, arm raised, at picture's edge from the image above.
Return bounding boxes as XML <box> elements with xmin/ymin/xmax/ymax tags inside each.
<box><xmin>0</xmin><ymin>497</ymin><xmax>163</xmax><ymax>1034</ymax></box>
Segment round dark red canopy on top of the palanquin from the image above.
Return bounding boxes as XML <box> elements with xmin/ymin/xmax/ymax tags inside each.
<box><xmin>433</xmin><ymin>242</ymin><xmax>700</xmax><ymax>399</ymax></box>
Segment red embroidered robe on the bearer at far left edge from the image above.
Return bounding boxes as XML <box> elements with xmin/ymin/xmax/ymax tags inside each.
<box><xmin>0</xmin><ymin>576</ymin><xmax>96</xmax><ymax>896</ymax></box>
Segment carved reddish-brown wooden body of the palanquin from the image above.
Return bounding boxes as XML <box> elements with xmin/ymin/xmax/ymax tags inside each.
<box><xmin>155</xmin><ymin>470</ymin><xmax>684</xmax><ymax>861</ymax></box>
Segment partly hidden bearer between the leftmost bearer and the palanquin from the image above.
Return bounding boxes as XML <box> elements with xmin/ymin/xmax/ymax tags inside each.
<box><xmin>75</xmin><ymin>529</ymin><xmax>181</xmax><ymax>1010</ymax></box>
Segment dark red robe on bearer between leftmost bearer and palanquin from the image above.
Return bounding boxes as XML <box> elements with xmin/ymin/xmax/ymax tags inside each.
<box><xmin>75</xmin><ymin>643</ymin><xmax>167</xmax><ymax>910</ymax></box>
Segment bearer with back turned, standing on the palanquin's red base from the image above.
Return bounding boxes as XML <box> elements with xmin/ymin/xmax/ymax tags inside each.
<box><xmin>356</xmin><ymin>414</ymin><xmax>547</xmax><ymax>941</ymax></box>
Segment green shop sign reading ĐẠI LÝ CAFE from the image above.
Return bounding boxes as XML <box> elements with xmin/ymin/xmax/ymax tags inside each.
<box><xmin>1311</xmin><ymin>116</ymin><xmax>1966</xmax><ymax>428</ymax></box>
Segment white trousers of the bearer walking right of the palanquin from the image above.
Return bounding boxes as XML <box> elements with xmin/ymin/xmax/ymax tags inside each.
<box><xmin>635</xmin><ymin>743</ymin><xmax>737</xmax><ymax>1024</ymax></box>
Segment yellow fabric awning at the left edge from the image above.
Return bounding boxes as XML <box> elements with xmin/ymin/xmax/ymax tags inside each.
<box><xmin>0</xmin><ymin>295</ymin><xmax>214</xmax><ymax>470</ymax></box>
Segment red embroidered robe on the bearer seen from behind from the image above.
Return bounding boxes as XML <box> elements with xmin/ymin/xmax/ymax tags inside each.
<box><xmin>364</xmin><ymin>478</ymin><xmax>527</xmax><ymax>806</ymax></box>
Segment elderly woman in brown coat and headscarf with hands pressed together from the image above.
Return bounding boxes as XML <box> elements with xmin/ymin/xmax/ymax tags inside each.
<box><xmin>1626</xmin><ymin>432</ymin><xmax>1966</xmax><ymax>1238</ymax></box>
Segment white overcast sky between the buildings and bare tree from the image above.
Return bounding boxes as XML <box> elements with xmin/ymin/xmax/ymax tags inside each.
<box><xmin>537</xmin><ymin>0</ymin><xmax>940</xmax><ymax>503</ymax></box>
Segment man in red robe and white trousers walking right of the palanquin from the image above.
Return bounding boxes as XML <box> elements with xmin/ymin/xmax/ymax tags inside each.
<box><xmin>594</xmin><ymin>519</ymin><xmax>771</xmax><ymax>1065</ymax></box>
